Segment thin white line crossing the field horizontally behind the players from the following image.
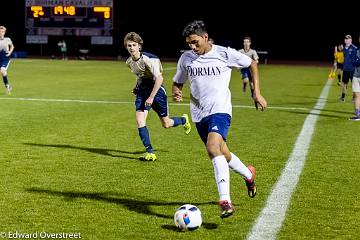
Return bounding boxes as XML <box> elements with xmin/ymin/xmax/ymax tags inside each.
<box><xmin>0</xmin><ymin>97</ymin><xmax>309</xmax><ymax>111</ymax></box>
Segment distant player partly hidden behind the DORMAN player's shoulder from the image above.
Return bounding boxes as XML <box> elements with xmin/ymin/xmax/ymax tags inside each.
<box><xmin>239</xmin><ymin>37</ymin><xmax>259</xmax><ymax>96</ymax></box>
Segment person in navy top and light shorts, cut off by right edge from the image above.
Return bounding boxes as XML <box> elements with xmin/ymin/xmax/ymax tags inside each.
<box><xmin>349</xmin><ymin>37</ymin><xmax>360</xmax><ymax>121</ymax></box>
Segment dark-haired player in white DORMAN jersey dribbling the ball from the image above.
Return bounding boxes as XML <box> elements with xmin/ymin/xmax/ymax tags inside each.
<box><xmin>172</xmin><ymin>21</ymin><xmax>267</xmax><ymax>218</ymax></box>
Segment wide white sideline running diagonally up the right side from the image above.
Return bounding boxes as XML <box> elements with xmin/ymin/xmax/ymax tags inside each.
<box><xmin>247</xmin><ymin>81</ymin><xmax>332</xmax><ymax>240</ymax></box>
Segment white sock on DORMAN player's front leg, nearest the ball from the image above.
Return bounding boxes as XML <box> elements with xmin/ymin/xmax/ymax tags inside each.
<box><xmin>212</xmin><ymin>155</ymin><xmax>231</xmax><ymax>202</ymax></box>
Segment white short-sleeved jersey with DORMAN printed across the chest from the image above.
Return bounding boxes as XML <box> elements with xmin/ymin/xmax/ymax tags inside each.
<box><xmin>173</xmin><ymin>45</ymin><xmax>251</xmax><ymax>122</ymax></box>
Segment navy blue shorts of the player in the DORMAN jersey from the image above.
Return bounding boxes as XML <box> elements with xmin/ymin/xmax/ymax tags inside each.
<box><xmin>196</xmin><ymin>113</ymin><xmax>231</xmax><ymax>144</ymax></box>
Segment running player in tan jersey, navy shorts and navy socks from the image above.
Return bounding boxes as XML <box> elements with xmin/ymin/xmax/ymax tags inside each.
<box><xmin>124</xmin><ymin>32</ymin><xmax>191</xmax><ymax>161</ymax></box>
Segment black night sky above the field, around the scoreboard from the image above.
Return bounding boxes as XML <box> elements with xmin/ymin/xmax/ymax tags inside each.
<box><xmin>0</xmin><ymin>0</ymin><xmax>360</xmax><ymax>62</ymax></box>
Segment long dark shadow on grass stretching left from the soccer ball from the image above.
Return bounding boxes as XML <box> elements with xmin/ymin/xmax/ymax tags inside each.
<box><xmin>26</xmin><ymin>187</ymin><xmax>218</xmax><ymax>231</ymax></box>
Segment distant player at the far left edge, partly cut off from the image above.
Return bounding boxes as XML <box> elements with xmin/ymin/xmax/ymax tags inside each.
<box><xmin>0</xmin><ymin>26</ymin><xmax>14</xmax><ymax>94</ymax></box>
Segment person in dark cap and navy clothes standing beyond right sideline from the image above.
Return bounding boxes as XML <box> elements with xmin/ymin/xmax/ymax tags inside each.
<box><xmin>339</xmin><ymin>34</ymin><xmax>357</xmax><ymax>102</ymax></box>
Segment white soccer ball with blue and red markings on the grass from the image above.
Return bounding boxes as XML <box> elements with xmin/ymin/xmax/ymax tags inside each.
<box><xmin>174</xmin><ymin>204</ymin><xmax>202</xmax><ymax>231</ymax></box>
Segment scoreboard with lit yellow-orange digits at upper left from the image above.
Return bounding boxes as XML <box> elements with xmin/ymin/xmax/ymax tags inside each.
<box><xmin>25</xmin><ymin>0</ymin><xmax>113</xmax><ymax>44</ymax></box>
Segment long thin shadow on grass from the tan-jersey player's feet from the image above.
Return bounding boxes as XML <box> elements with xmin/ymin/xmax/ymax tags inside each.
<box><xmin>24</xmin><ymin>143</ymin><xmax>164</xmax><ymax>160</ymax></box>
